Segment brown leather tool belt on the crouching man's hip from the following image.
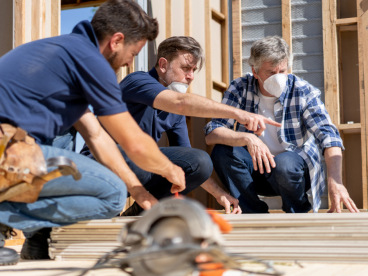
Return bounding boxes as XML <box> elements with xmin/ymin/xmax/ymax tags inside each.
<box><xmin>0</xmin><ymin>124</ymin><xmax>80</xmax><ymax>203</ymax></box>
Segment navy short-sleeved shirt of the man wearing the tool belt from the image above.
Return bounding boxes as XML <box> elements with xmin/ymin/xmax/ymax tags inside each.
<box><xmin>0</xmin><ymin>21</ymin><xmax>127</xmax><ymax>143</ymax></box>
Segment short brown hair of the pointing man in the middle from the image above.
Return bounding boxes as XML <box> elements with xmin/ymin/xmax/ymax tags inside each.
<box><xmin>156</xmin><ymin>36</ymin><xmax>204</xmax><ymax>70</ymax></box>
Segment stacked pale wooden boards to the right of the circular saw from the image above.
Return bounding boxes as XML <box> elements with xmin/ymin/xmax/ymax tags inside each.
<box><xmin>223</xmin><ymin>213</ymin><xmax>368</xmax><ymax>262</ymax></box>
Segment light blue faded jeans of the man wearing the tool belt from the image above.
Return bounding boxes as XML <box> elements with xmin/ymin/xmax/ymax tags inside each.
<box><xmin>0</xmin><ymin>146</ymin><xmax>127</xmax><ymax>236</ymax></box>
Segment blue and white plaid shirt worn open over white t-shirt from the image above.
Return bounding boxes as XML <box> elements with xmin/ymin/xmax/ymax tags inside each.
<box><xmin>205</xmin><ymin>73</ymin><xmax>344</xmax><ymax>212</ymax></box>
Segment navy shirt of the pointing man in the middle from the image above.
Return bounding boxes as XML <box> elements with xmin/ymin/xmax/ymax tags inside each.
<box><xmin>120</xmin><ymin>68</ymin><xmax>191</xmax><ymax>147</ymax></box>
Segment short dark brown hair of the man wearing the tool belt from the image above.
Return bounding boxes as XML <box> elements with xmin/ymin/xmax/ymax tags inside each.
<box><xmin>91</xmin><ymin>0</ymin><xmax>158</xmax><ymax>43</ymax></box>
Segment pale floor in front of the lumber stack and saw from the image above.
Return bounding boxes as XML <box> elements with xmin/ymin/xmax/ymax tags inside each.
<box><xmin>0</xmin><ymin>246</ymin><xmax>368</xmax><ymax>276</ymax></box>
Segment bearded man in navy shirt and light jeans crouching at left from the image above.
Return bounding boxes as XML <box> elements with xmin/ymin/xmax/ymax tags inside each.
<box><xmin>0</xmin><ymin>0</ymin><xmax>185</xmax><ymax>265</ymax></box>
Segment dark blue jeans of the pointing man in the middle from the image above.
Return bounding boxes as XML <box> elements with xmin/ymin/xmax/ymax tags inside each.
<box><xmin>119</xmin><ymin>146</ymin><xmax>213</xmax><ymax>199</ymax></box>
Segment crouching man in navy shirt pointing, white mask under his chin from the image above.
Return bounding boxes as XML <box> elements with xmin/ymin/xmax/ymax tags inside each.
<box><xmin>82</xmin><ymin>36</ymin><xmax>278</xmax><ymax>215</ymax></box>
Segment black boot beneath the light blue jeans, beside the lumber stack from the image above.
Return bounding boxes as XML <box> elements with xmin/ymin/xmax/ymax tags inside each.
<box><xmin>20</xmin><ymin>228</ymin><xmax>51</xmax><ymax>260</ymax></box>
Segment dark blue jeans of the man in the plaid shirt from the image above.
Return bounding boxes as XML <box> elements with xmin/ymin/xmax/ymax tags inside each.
<box><xmin>211</xmin><ymin>145</ymin><xmax>311</xmax><ymax>213</ymax></box>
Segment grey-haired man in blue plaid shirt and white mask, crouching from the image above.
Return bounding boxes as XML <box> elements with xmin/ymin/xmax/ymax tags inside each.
<box><xmin>206</xmin><ymin>36</ymin><xmax>359</xmax><ymax>213</ymax></box>
